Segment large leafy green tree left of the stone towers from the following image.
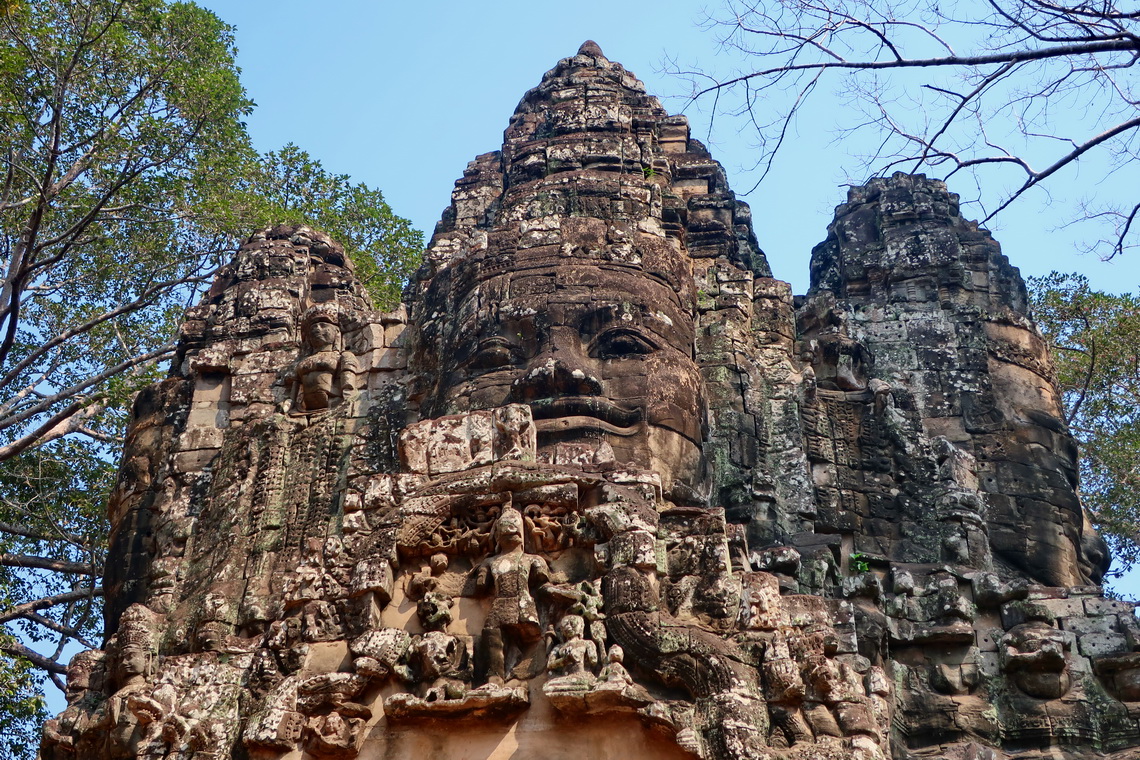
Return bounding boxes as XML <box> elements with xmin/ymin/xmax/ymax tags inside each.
<box><xmin>0</xmin><ymin>0</ymin><xmax>421</xmax><ymax>757</ymax></box>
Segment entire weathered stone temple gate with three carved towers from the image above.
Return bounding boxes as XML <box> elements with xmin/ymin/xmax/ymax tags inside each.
<box><xmin>42</xmin><ymin>42</ymin><xmax>1140</xmax><ymax>760</ymax></box>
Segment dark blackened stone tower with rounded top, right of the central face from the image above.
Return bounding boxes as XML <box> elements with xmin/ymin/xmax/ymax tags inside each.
<box><xmin>800</xmin><ymin>175</ymin><xmax>1107</xmax><ymax>586</ymax></box>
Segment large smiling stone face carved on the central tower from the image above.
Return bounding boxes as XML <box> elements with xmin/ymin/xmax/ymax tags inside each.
<box><xmin>419</xmin><ymin>253</ymin><xmax>703</xmax><ymax>489</ymax></box>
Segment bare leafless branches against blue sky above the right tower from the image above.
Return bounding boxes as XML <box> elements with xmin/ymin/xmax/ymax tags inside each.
<box><xmin>677</xmin><ymin>0</ymin><xmax>1140</xmax><ymax>255</ymax></box>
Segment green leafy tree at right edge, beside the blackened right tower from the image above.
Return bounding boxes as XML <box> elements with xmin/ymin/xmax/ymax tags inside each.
<box><xmin>1028</xmin><ymin>272</ymin><xmax>1140</xmax><ymax>569</ymax></box>
